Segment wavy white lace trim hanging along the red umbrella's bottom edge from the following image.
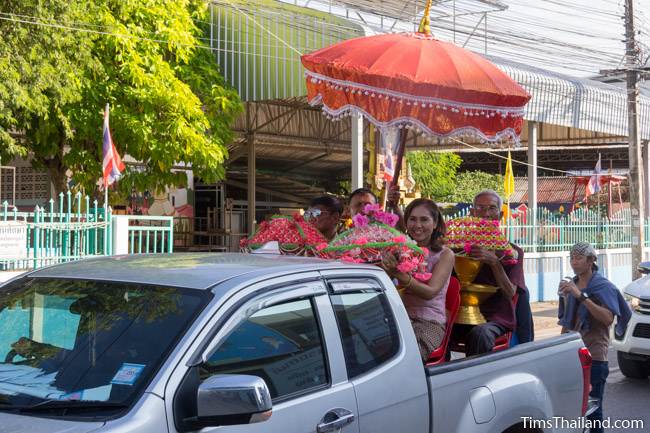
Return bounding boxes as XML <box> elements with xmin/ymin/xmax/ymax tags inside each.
<box><xmin>309</xmin><ymin>95</ymin><xmax>521</xmax><ymax>147</ymax></box>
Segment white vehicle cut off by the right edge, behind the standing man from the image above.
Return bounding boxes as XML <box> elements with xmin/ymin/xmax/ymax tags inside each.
<box><xmin>611</xmin><ymin>262</ymin><xmax>650</xmax><ymax>379</ymax></box>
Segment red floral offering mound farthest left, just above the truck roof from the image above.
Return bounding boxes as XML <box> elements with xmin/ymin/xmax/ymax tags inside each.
<box><xmin>239</xmin><ymin>213</ymin><xmax>327</xmax><ymax>256</ymax></box>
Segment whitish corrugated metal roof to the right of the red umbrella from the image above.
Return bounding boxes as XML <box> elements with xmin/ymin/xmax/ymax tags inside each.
<box><xmin>487</xmin><ymin>56</ymin><xmax>650</xmax><ymax>140</ymax></box>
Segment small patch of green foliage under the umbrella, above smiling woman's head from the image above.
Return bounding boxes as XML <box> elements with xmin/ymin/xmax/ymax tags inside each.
<box><xmin>407</xmin><ymin>151</ymin><xmax>462</xmax><ymax>202</ymax></box>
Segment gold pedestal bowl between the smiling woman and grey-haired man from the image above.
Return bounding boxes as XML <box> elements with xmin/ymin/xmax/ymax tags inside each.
<box><xmin>454</xmin><ymin>256</ymin><xmax>497</xmax><ymax>325</ymax></box>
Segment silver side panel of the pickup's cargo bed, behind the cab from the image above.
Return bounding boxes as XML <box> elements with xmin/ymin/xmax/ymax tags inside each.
<box><xmin>426</xmin><ymin>333</ymin><xmax>583</xmax><ymax>433</ymax></box>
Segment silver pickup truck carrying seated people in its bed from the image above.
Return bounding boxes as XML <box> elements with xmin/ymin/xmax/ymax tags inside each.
<box><xmin>0</xmin><ymin>254</ymin><xmax>590</xmax><ymax>433</ymax></box>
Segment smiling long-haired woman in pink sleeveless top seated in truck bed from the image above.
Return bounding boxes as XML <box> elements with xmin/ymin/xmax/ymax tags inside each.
<box><xmin>381</xmin><ymin>199</ymin><xmax>454</xmax><ymax>362</ymax></box>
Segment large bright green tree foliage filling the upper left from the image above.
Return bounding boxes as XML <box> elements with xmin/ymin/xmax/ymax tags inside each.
<box><xmin>0</xmin><ymin>0</ymin><xmax>241</xmax><ymax>192</ymax></box>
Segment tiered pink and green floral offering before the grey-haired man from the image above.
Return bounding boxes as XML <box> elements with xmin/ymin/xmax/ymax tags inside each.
<box><xmin>447</xmin><ymin>217</ymin><xmax>517</xmax><ymax>265</ymax></box>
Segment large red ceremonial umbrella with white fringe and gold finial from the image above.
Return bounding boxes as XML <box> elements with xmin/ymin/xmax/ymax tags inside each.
<box><xmin>301</xmin><ymin>0</ymin><xmax>530</xmax><ymax>186</ymax></box>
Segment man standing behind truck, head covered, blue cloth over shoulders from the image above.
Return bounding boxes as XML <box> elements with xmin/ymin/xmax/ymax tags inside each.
<box><xmin>558</xmin><ymin>242</ymin><xmax>632</xmax><ymax>433</ymax></box>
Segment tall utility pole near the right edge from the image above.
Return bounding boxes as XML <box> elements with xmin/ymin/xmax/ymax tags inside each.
<box><xmin>625</xmin><ymin>0</ymin><xmax>645</xmax><ymax>279</ymax></box>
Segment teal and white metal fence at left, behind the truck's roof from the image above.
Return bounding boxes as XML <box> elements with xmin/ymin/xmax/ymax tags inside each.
<box><xmin>0</xmin><ymin>191</ymin><xmax>174</xmax><ymax>271</ymax></box>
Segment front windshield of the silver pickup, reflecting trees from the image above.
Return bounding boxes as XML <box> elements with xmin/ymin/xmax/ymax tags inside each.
<box><xmin>0</xmin><ymin>278</ymin><xmax>211</xmax><ymax>416</ymax></box>
